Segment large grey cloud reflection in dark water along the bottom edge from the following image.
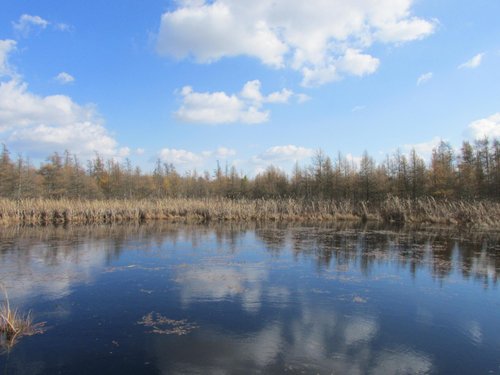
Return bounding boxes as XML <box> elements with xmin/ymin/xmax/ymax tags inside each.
<box><xmin>149</xmin><ymin>308</ymin><xmax>433</xmax><ymax>374</ymax></box>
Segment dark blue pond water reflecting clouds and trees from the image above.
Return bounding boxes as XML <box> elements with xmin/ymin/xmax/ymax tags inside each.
<box><xmin>0</xmin><ymin>224</ymin><xmax>500</xmax><ymax>374</ymax></box>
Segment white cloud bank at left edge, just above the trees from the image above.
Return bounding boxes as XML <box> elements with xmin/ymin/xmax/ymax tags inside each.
<box><xmin>0</xmin><ymin>40</ymin><xmax>125</xmax><ymax>157</ymax></box>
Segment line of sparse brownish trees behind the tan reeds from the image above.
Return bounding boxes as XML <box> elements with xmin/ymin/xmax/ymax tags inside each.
<box><xmin>0</xmin><ymin>138</ymin><xmax>500</xmax><ymax>201</ymax></box>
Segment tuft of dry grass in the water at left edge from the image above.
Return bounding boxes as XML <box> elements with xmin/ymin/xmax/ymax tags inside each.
<box><xmin>0</xmin><ymin>286</ymin><xmax>45</xmax><ymax>353</ymax></box>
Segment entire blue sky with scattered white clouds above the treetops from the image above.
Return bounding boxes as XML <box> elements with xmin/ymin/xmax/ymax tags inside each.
<box><xmin>0</xmin><ymin>0</ymin><xmax>500</xmax><ymax>175</ymax></box>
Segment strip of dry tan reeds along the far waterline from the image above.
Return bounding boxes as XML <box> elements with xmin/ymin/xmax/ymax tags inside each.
<box><xmin>0</xmin><ymin>197</ymin><xmax>500</xmax><ymax>228</ymax></box>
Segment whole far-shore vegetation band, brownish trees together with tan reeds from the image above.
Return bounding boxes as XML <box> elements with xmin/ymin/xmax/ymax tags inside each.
<box><xmin>0</xmin><ymin>139</ymin><xmax>500</xmax><ymax>228</ymax></box>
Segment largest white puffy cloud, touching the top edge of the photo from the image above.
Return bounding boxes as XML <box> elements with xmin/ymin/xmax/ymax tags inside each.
<box><xmin>157</xmin><ymin>0</ymin><xmax>437</xmax><ymax>86</ymax></box>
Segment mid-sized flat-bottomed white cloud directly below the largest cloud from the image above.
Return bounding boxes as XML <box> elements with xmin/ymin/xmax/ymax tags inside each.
<box><xmin>175</xmin><ymin>80</ymin><xmax>300</xmax><ymax>124</ymax></box>
